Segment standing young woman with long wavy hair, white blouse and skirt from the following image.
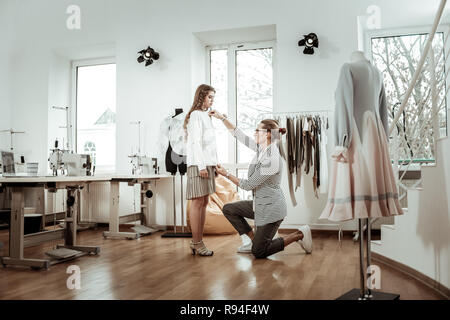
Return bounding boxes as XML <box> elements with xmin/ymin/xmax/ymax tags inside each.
<box><xmin>184</xmin><ymin>84</ymin><xmax>217</xmax><ymax>256</ymax></box>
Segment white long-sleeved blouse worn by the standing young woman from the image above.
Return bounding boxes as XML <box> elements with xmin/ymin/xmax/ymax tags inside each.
<box><xmin>186</xmin><ymin>110</ymin><xmax>217</xmax><ymax>170</ymax></box>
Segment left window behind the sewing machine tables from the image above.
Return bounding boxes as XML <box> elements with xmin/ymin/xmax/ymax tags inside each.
<box><xmin>73</xmin><ymin>60</ymin><xmax>116</xmax><ymax>172</ymax></box>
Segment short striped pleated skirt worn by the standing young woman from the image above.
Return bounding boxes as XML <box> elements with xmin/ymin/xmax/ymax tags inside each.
<box><xmin>186</xmin><ymin>166</ymin><xmax>216</xmax><ymax>200</ymax></box>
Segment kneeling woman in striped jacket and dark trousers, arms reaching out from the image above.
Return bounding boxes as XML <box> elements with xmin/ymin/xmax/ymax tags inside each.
<box><xmin>210</xmin><ymin>111</ymin><xmax>312</xmax><ymax>258</ymax></box>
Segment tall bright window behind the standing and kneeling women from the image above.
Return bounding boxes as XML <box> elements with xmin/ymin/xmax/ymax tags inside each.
<box><xmin>207</xmin><ymin>42</ymin><xmax>274</xmax><ymax>178</ymax></box>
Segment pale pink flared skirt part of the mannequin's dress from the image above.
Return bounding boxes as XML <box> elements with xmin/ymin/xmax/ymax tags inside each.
<box><xmin>320</xmin><ymin>111</ymin><xmax>403</xmax><ymax>221</ymax></box>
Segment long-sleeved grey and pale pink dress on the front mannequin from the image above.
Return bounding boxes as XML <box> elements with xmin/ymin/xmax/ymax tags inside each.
<box><xmin>320</xmin><ymin>60</ymin><xmax>403</xmax><ymax>221</ymax></box>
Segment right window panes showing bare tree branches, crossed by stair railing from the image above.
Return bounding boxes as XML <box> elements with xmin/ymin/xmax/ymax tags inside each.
<box><xmin>370</xmin><ymin>31</ymin><xmax>447</xmax><ymax>162</ymax></box>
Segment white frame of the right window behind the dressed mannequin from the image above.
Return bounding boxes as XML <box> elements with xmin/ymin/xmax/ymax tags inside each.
<box><xmin>364</xmin><ymin>24</ymin><xmax>450</xmax><ymax>145</ymax></box>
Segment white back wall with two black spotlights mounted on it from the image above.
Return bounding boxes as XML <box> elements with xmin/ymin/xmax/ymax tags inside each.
<box><xmin>0</xmin><ymin>0</ymin><xmax>446</xmax><ymax>228</ymax></box>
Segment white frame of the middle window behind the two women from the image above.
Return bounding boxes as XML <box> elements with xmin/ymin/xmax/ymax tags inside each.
<box><xmin>205</xmin><ymin>40</ymin><xmax>277</xmax><ymax>174</ymax></box>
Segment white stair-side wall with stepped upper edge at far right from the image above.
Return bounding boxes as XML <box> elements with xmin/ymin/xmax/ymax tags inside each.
<box><xmin>372</xmin><ymin>138</ymin><xmax>450</xmax><ymax>288</ymax></box>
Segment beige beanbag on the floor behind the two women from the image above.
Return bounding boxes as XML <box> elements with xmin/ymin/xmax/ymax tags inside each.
<box><xmin>186</xmin><ymin>176</ymin><xmax>240</xmax><ymax>234</ymax></box>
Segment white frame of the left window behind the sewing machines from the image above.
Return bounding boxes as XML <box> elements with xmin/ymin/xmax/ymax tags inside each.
<box><xmin>69</xmin><ymin>57</ymin><xmax>117</xmax><ymax>173</ymax></box>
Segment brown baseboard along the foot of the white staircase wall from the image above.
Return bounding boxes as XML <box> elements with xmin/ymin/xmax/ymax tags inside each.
<box><xmin>372</xmin><ymin>252</ymin><xmax>450</xmax><ymax>299</ymax></box>
